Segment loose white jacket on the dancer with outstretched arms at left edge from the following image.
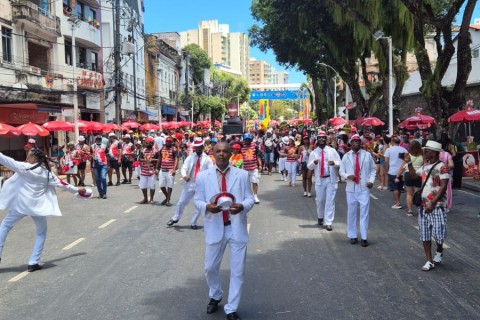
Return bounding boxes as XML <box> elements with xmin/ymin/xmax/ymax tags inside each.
<box><xmin>0</xmin><ymin>152</ymin><xmax>78</xmax><ymax>216</ymax></box>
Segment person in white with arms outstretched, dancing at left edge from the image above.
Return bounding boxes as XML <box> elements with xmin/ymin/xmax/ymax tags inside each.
<box><xmin>0</xmin><ymin>148</ymin><xmax>86</xmax><ymax>272</ymax></box>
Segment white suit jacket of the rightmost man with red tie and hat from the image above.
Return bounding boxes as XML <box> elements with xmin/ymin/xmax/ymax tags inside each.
<box><xmin>340</xmin><ymin>149</ymin><xmax>377</xmax><ymax>192</ymax></box>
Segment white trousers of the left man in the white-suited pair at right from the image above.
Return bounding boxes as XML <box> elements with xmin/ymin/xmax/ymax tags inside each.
<box><xmin>315</xmin><ymin>178</ymin><xmax>338</xmax><ymax>226</ymax></box>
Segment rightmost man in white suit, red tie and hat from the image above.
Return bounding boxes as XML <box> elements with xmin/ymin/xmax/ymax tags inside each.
<box><xmin>340</xmin><ymin>134</ymin><xmax>376</xmax><ymax>247</ymax></box>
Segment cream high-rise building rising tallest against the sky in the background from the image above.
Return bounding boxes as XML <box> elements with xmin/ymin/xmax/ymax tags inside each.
<box><xmin>180</xmin><ymin>20</ymin><xmax>250</xmax><ymax>79</ymax></box>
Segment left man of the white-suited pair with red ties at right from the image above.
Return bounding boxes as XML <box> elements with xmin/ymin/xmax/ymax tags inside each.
<box><xmin>307</xmin><ymin>131</ymin><xmax>341</xmax><ymax>231</ymax></box>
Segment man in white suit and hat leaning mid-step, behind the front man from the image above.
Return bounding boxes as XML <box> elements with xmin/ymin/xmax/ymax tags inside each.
<box><xmin>167</xmin><ymin>138</ymin><xmax>213</xmax><ymax>230</ymax></box>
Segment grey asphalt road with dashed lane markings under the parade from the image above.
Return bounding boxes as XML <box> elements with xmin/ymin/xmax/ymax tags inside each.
<box><xmin>0</xmin><ymin>174</ymin><xmax>480</xmax><ymax>320</ymax></box>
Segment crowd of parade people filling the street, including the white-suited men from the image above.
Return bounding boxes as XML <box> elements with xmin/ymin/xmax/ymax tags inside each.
<box><xmin>0</xmin><ymin>122</ymin><xmax>474</xmax><ymax>319</ymax></box>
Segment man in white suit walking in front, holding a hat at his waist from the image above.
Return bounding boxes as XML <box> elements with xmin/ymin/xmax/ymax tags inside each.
<box><xmin>195</xmin><ymin>142</ymin><xmax>255</xmax><ymax>320</ymax></box>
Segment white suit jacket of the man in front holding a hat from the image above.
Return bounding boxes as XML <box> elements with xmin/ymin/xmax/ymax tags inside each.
<box><xmin>195</xmin><ymin>166</ymin><xmax>255</xmax><ymax>244</ymax></box>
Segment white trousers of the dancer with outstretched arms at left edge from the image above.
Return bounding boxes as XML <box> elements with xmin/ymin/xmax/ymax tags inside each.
<box><xmin>0</xmin><ymin>210</ymin><xmax>47</xmax><ymax>265</ymax></box>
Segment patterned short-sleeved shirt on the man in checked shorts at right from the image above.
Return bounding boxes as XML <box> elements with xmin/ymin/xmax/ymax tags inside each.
<box><xmin>417</xmin><ymin>163</ymin><xmax>450</xmax><ymax>207</ymax></box>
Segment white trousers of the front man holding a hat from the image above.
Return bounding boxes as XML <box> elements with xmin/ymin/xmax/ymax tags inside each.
<box><xmin>205</xmin><ymin>226</ymin><xmax>247</xmax><ymax>314</ymax></box>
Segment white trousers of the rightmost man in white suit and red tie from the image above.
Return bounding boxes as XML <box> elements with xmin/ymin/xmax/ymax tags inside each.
<box><xmin>347</xmin><ymin>190</ymin><xmax>370</xmax><ymax>240</ymax></box>
